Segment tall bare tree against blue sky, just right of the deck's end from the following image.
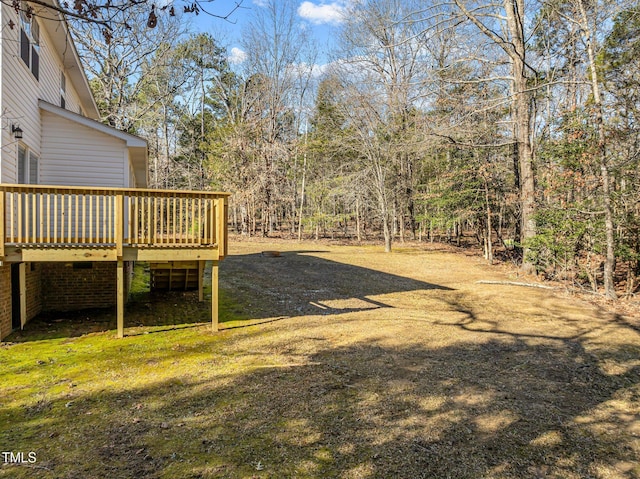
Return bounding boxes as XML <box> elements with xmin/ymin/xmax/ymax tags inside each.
<box><xmin>242</xmin><ymin>0</ymin><xmax>310</xmax><ymax>234</ymax></box>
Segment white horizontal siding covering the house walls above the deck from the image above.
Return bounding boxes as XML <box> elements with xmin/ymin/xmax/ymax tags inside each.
<box><xmin>0</xmin><ymin>3</ymin><xmax>146</xmax><ymax>187</ymax></box>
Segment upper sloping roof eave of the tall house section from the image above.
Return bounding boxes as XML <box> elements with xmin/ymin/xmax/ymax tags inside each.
<box><xmin>39</xmin><ymin>0</ymin><xmax>100</xmax><ymax>119</ymax></box>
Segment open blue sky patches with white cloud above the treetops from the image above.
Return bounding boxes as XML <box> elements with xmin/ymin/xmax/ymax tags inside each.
<box><xmin>186</xmin><ymin>0</ymin><xmax>349</xmax><ymax>63</ymax></box>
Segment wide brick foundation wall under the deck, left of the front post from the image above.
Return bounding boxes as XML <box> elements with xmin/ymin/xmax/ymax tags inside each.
<box><xmin>42</xmin><ymin>262</ymin><xmax>116</xmax><ymax>311</ymax></box>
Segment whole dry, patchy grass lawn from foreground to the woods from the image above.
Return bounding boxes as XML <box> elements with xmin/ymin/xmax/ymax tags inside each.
<box><xmin>0</xmin><ymin>241</ymin><xmax>640</xmax><ymax>479</ymax></box>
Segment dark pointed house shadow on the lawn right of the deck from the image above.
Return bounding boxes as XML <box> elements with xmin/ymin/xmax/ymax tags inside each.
<box><xmin>220</xmin><ymin>251</ymin><xmax>451</xmax><ymax>319</ymax></box>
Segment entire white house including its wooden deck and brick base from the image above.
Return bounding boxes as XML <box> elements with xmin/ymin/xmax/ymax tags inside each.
<box><xmin>0</xmin><ymin>0</ymin><xmax>226</xmax><ymax>339</ymax></box>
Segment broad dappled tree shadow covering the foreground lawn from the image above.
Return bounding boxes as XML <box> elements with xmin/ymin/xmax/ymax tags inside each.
<box><xmin>0</xmin><ymin>325</ymin><xmax>640</xmax><ymax>479</ymax></box>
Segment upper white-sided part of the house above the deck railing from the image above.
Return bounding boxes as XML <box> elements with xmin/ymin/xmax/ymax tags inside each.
<box><xmin>0</xmin><ymin>0</ymin><xmax>147</xmax><ymax>188</ymax></box>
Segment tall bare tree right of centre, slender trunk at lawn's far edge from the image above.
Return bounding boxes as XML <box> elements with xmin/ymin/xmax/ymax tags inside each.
<box><xmin>338</xmin><ymin>0</ymin><xmax>427</xmax><ymax>251</ymax></box>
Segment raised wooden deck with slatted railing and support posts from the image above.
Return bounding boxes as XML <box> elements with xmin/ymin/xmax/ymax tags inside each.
<box><xmin>0</xmin><ymin>184</ymin><xmax>229</xmax><ymax>337</ymax></box>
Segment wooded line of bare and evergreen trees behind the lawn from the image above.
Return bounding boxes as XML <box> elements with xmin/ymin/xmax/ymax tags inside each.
<box><xmin>70</xmin><ymin>0</ymin><xmax>640</xmax><ymax>298</ymax></box>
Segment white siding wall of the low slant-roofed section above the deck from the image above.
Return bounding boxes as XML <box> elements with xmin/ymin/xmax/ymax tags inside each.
<box><xmin>40</xmin><ymin>111</ymin><xmax>129</xmax><ymax>187</ymax></box>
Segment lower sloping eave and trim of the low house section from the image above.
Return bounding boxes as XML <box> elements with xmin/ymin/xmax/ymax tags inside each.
<box><xmin>38</xmin><ymin>100</ymin><xmax>147</xmax><ymax>188</ymax></box>
